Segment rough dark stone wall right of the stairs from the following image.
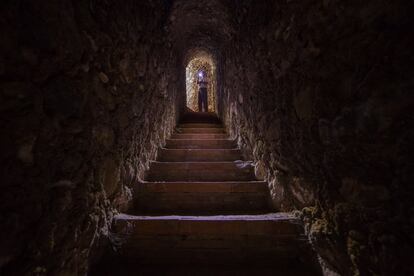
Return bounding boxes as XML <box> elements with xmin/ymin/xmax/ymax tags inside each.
<box><xmin>220</xmin><ymin>0</ymin><xmax>414</xmax><ymax>275</ymax></box>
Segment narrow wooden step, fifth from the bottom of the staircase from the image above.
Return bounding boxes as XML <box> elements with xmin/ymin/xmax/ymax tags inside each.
<box><xmin>165</xmin><ymin>139</ymin><xmax>236</xmax><ymax>149</ymax></box>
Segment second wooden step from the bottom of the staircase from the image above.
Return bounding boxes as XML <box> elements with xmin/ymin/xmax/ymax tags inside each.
<box><xmin>134</xmin><ymin>181</ymin><xmax>270</xmax><ymax>215</ymax></box>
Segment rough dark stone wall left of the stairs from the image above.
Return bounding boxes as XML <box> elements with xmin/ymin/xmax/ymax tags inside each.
<box><xmin>0</xmin><ymin>0</ymin><xmax>184</xmax><ymax>275</ymax></box>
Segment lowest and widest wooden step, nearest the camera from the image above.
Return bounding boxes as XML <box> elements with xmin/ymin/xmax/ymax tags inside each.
<box><xmin>112</xmin><ymin>213</ymin><xmax>306</xmax><ymax>264</ymax></box>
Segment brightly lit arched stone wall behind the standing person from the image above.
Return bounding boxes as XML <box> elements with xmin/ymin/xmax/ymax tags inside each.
<box><xmin>185</xmin><ymin>50</ymin><xmax>217</xmax><ymax>112</ymax></box>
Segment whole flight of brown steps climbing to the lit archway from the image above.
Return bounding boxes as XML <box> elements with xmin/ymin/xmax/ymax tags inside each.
<box><xmin>93</xmin><ymin>113</ymin><xmax>318</xmax><ymax>275</ymax></box>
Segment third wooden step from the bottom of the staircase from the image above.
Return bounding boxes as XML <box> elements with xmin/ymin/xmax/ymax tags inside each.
<box><xmin>145</xmin><ymin>161</ymin><xmax>256</xmax><ymax>182</ymax></box>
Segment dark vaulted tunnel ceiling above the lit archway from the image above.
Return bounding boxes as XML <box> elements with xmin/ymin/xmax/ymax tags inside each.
<box><xmin>169</xmin><ymin>0</ymin><xmax>233</xmax><ymax>56</ymax></box>
